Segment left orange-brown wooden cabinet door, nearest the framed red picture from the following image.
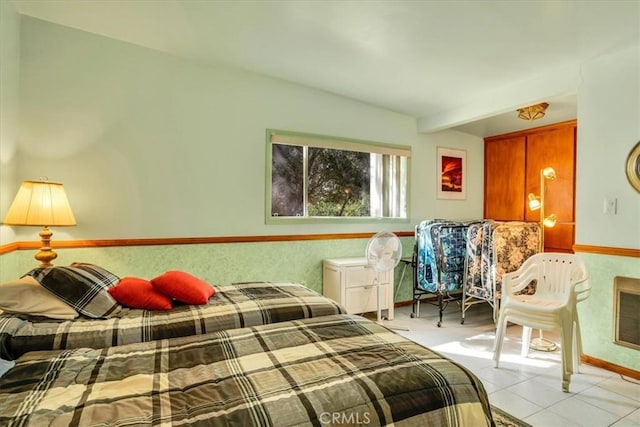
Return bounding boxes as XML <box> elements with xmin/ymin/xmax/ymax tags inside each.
<box><xmin>484</xmin><ymin>136</ymin><xmax>526</xmax><ymax>221</ymax></box>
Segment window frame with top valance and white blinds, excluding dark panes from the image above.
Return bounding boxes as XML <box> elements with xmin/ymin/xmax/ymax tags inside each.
<box><xmin>265</xmin><ymin>129</ymin><xmax>411</xmax><ymax>224</ymax></box>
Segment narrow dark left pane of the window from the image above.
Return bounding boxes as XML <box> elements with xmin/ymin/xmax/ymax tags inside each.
<box><xmin>271</xmin><ymin>144</ymin><xmax>304</xmax><ymax>216</ymax></box>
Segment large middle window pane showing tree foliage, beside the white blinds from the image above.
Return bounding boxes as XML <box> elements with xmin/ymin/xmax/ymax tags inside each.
<box><xmin>307</xmin><ymin>147</ymin><xmax>371</xmax><ymax>216</ymax></box>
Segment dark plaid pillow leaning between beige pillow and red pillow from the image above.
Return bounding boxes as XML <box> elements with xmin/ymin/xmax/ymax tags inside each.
<box><xmin>25</xmin><ymin>263</ymin><xmax>122</xmax><ymax>319</ymax></box>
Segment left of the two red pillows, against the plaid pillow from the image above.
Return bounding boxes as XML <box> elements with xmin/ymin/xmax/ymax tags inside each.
<box><xmin>107</xmin><ymin>277</ymin><xmax>173</xmax><ymax>310</ymax></box>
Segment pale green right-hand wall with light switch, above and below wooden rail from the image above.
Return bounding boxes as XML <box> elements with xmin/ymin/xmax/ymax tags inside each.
<box><xmin>575</xmin><ymin>45</ymin><xmax>640</xmax><ymax>371</ymax></box>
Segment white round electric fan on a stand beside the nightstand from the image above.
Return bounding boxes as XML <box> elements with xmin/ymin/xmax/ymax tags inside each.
<box><xmin>365</xmin><ymin>231</ymin><xmax>402</xmax><ymax>322</ymax></box>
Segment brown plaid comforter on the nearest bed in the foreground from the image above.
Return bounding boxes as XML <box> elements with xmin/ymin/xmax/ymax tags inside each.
<box><xmin>0</xmin><ymin>315</ymin><xmax>493</xmax><ymax>427</ymax></box>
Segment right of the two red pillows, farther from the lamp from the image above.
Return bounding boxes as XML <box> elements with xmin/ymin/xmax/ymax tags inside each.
<box><xmin>151</xmin><ymin>271</ymin><xmax>216</xmax><ymax>304</ymax></box>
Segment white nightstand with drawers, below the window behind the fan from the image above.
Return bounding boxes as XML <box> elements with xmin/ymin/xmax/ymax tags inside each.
<box><xmin>322</xmin><ymin>257</ymin><xmax>393</xmax><ymax>320</ymax></box>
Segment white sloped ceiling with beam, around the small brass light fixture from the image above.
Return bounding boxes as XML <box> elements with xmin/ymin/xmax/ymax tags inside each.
<box><xmin>14</xmin><ymin>0</ymin><xmax>640</xmax><ymax>136</ymax></box>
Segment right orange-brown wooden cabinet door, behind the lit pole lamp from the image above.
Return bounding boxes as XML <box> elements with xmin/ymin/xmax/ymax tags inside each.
<box><xmin>525</xmin><ymin>125</ymin><xmax>575</xmax><ymax>252</ymax></box>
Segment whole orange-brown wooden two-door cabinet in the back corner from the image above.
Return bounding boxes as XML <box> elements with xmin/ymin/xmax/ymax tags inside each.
<box><xmin>484</xmin><ymin>120</ymin><xmax>576</xmax><ymax>252</ymax></box>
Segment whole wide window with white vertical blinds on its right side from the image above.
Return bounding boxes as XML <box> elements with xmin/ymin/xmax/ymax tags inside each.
<box><xmin>267</xmin><ymin>130</ymin><xmax>411</xmax><ymax>222</ymax></box>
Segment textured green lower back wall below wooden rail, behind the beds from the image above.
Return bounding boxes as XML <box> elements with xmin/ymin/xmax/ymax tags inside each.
<box><xmin>0</xmin><ymin>237</ymin><xmax>414</xmax><ymax>301</ymax></box>
